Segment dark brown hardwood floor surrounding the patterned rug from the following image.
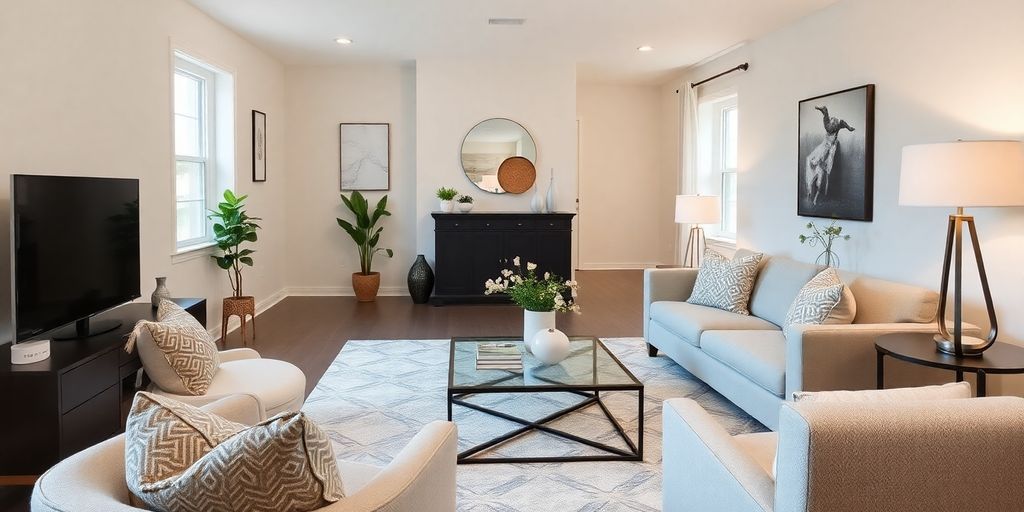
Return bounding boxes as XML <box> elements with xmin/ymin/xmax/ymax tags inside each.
<box><xmin>0</xmin><ymin>270</ymin><xmax>643</xmax><ymax>511</ymax></box>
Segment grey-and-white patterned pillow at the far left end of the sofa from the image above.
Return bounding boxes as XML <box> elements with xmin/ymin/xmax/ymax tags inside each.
<box><xmin>686</xmin><ymin>249</ymin><xmax>764</xmax><ymax>314</ymax></box>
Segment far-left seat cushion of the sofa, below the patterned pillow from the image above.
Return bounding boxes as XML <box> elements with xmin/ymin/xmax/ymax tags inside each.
<box><xmin>650</xmin><ymin>301</ymin><xmax>779</xmax><ymax>347</ymax></box>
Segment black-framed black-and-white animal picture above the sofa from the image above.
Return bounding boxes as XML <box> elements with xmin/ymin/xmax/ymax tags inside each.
<box><xmin>797</xmin><ymin>84</ymin><xmax>874</xmax><ymax>221</ymax></box>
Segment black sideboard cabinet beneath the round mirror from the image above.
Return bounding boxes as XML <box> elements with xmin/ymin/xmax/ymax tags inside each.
<box><xmin>431</xmin><ymin>212</ymin><xmax>575</xmax><ymax>305</ymax></box>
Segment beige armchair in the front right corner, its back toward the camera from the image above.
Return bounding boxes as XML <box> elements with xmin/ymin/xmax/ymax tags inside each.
<box><xmin>663</xmin><ymin>396</ymin><xmax>1024</xmax><ymax>512</ymax></box>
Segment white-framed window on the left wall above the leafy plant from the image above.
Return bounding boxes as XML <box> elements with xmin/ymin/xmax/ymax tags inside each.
<box><xmin>173</xmin><ymin>52</ymin><xmax>233</xmax><ymax>252</ymax></box>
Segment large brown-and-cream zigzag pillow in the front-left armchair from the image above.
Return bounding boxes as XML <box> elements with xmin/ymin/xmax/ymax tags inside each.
<box><xmin>125</xmin><ymin>393</ymin><xmax>344</xmax><ymax>512</ymax></box>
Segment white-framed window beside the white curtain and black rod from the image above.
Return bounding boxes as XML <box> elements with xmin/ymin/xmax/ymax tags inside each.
<box><xmin>696</xmin><ymin>93</ymin><xmax>739</xmax><ymax>242</ymax></box>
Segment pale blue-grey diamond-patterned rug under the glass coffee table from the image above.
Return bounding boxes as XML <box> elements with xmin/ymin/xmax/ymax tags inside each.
<box><xmin>303</xmin><ymin>338</ymin><xmax>766</xmax><ymax>512</ymax></box>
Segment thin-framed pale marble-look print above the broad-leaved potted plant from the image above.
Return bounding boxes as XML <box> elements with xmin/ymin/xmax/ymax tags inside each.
<box><xmin>339</xmin><ymin>123</ymin><xmax>391</xmax><ymax>190</ymax></box>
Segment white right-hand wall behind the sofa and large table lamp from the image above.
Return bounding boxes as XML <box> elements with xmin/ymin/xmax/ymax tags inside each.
<box><xmin>664</xmin><ymin>0</ymin><xmax>1024</xmax><ymax>394</ymax></box>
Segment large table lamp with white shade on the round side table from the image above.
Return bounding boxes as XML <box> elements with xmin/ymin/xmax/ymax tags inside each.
<box><xmin>899</xmin><ymin>140</ymin><xmax>1024</xmax><ymax>357</ymax></box>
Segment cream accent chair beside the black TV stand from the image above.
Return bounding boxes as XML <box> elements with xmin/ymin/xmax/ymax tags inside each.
<box><xmin>135</xmin><ymin>321</ymin><xmax>306</xmax><ymax>420</ymax></box>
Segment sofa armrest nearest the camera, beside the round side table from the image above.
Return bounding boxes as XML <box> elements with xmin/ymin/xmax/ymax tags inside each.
<box><xmin>785</xmin><ymin>323</ymin><xmax>980</xmax><ymax>399</ymax></box>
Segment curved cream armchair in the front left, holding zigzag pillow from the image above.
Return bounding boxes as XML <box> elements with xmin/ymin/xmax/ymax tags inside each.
<box><xmin>32</xmin><ymin>395</ymin><xmax>458</xmax><ymax>512</ymax></box>
